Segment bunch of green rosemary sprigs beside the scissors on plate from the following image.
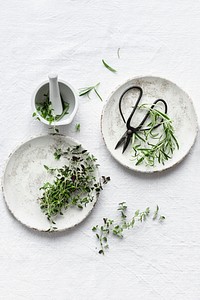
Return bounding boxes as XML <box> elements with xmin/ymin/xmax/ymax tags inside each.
<box><xmin>132</xmin><ymin>104</ymin><xmax>179</xmax><ymax>166</ymax></box>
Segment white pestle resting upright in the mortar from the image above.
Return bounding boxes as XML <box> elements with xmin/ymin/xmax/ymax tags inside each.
<box><xmin>49</xmin><ymin>73</ymin><xmax>63</xmax><ymax>115</ymax></box>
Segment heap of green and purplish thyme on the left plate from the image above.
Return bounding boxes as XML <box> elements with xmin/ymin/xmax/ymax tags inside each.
<box><xmin>39</xmin><ymin>145</ymin><xmax>106</xmax><ymax>224</ymax></box>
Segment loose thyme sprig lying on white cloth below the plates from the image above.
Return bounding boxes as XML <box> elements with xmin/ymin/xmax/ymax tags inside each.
<box><xmin>92</xmin><ymin>202</ymin><xmax>165</xmax><ymax>255</ymax></box>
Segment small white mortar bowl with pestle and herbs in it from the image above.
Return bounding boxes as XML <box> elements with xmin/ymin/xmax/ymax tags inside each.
<box><xmin>32</xmin><ymin>79</ymin><xmax>78</xmax><ymax>126</ymax></box>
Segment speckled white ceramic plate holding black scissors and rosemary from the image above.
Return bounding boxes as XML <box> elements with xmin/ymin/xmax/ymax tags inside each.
<box><xmin>101</xmin><ymin>76</ymin><xmax>198</xmax><ymax>173</ymax></box>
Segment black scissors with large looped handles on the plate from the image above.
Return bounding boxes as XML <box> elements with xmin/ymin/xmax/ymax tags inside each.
<box><xmin>115</xmin><ymin>86</ymin><xmax>167</xmax><ymax>153</ymax></box>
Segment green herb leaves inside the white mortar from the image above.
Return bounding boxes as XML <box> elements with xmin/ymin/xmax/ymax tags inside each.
<box><xmin>32</xmin><ymin>94</ymin><xmax>69</xmax><ymax>125</ymax></box>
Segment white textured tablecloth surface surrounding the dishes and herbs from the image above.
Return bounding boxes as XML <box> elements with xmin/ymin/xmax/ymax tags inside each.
<box><xmin>0</xmin><ymin>0</ymin><xmax>200</xmax><ymax>300</ymax></box>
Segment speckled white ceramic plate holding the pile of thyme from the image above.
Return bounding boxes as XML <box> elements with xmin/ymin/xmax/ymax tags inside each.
<box><xmin>3</xmin><ymin>135</ymin><xmax>98</xmax><ymax>231</ymax></box>
